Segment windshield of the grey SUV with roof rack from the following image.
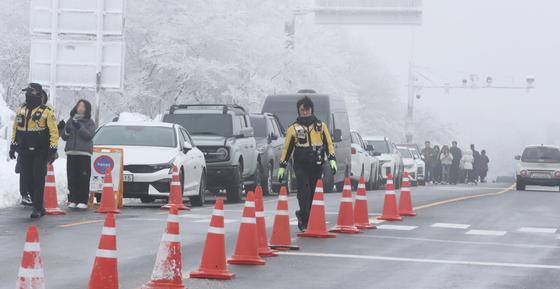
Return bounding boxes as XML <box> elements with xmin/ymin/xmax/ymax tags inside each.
<box><xmin>163</xmin><ymin>113</ymin><xmax>233</xmax><ymax>137</ymax></box>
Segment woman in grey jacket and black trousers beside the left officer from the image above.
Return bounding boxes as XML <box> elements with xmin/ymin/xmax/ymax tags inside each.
<box><xmin>61</xmin><ymin>99</ymin><xmax>95</xmax><ymax>209</ymax></box>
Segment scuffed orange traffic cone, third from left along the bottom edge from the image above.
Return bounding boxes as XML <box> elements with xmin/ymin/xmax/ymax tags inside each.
<box><xmin>140</xmin><ymin>205</ymin><xmax>185</xmax><ymax>289</ymax></box>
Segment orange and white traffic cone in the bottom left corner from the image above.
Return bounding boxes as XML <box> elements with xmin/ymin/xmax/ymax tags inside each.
<box><xmin>16</xmin><ymin>225</ymin><xmax>45</xmax><ymax>289</ymax></box>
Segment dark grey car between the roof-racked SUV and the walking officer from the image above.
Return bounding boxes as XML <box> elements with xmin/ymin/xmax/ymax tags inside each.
<box><xmin>251</xmin><ymin>113</ymin><xmax>284</xmax><ymax>195</ymax></box>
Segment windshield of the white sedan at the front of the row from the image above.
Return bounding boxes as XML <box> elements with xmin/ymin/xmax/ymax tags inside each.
<box><xmin>93</xmin><ymin>125</ymin><xmax>177</xmax><ymax>147</ymax></box>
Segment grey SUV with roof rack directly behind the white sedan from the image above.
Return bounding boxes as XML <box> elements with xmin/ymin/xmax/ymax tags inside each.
<box><xmin>163</xmin><ymin>104</ymin><xmax>262</xmax><ymax>203</ymax></box>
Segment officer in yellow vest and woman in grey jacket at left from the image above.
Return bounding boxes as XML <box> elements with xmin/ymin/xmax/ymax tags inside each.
<box><xmin>9</xmin><ymin>83</ymin><xmax>96</xmax><ymax>218</ymax></box>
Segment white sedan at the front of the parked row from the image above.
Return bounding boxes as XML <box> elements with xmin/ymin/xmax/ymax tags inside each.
<box><xmin>93</xmin><ymin>122</ymin><xmax>207</xmax><ymax>206</ymax></box>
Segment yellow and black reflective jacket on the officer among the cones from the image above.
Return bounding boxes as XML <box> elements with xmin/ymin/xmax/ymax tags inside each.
<box><xmin>280</xmin><ymin>121</ymin><xmax>335</xmax><ymax>168</ymax></box>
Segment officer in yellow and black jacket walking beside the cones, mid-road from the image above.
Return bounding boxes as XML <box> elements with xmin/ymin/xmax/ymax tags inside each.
<box><xmin>278</xmin><ymin>96</ymin><xmax>336</xmax><ymax>231</ymax></box>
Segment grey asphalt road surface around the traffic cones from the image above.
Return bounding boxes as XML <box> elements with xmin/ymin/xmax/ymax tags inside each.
<box><xmin>0</xmin><ymin>184</ymin><xmax>560</xmax><ymax>289</ymax></box>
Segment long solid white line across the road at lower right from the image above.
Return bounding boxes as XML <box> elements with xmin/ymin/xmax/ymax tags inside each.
<box><xmin>278</xmin><ymin>251</ymin><xmax>560</xmax><ymax>270</ymax></box>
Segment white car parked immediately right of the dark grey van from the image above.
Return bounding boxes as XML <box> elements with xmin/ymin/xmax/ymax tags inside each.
<box><xmin>350</xmin><ymin>130</ymin><xmax>378</xmax><ymax>188</ymax></box>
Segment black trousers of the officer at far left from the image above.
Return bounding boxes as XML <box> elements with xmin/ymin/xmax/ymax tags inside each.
<box><xmin>20</xmin><ymin>150</ymin><xmax>47</xmax><ymax>211</ymax></box>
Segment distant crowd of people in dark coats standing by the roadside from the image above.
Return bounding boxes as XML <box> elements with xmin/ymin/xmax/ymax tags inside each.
<box><xmin>421</xmin><ymin>141</ymin><xmax>490</xmax><ymax>184</ymax></box>
